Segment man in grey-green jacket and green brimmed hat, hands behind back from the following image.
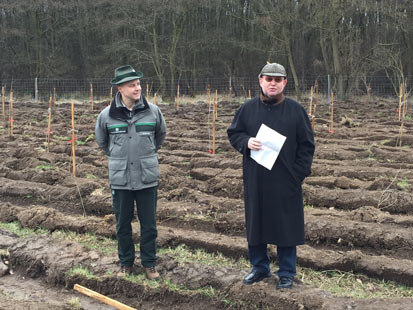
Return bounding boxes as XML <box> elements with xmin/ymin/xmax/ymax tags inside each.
<box><xmin>95</xmin><ymin>65</ymin><xmax>166</xmax><ymax>279</ymax></box>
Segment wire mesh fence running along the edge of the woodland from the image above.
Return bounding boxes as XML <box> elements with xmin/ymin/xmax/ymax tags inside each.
<box><xmin>0</xmin><ymin>76</ymin><xmax>413</xmax><ymax>101</ymax></box>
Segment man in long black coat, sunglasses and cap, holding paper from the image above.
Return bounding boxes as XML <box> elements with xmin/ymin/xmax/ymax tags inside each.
<box><xmin>227</xmin><ymin>63</ymin><xmax>315</xmax><ymax>288</ymax></box>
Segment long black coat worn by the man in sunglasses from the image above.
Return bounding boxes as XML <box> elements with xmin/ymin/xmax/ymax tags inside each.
<box><xmin>227</xmin><ymin>97</ymin><xmax>315</xmax><ymax>246</ymax></box>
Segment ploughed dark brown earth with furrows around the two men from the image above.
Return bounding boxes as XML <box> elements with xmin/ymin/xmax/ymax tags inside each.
<box><xmin>0</xmin><ymin>95</ymin><xmax>413</xmax><ymax>309</ymax></box>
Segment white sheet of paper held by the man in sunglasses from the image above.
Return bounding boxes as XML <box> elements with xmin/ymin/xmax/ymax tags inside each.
<box><xmin>251</xmin><ymin>124</ymin><xmax>287</xmax><ymax>170</ymax></box>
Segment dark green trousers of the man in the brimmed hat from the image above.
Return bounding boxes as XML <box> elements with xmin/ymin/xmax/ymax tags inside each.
<box><xmin>112</xmin><ymin>186</ymin><xmax>158</xmax><ymax>267</ymax></box>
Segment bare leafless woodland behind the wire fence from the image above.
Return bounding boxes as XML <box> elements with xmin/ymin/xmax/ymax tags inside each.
<box><xmin>0</xmin><ymin>0</ymin><xmax>413</xmax><ymax>96</ymax></box>
